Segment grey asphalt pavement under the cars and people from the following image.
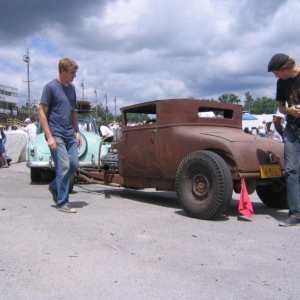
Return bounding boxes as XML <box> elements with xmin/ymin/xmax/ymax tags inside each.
<box><xmin>0</xmin><ymin>163</ymin><xmax>300</xmax><ymax>300</ymax></box>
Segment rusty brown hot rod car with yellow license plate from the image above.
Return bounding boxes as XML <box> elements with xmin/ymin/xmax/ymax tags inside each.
<box><xmin>79</xmin><ymin>99</ymin><xmax>286</xmax><ymax>219</ymax></box>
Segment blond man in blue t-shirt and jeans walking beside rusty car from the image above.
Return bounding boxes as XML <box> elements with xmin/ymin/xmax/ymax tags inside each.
<box><xmin>39</xmin><ymin>58</ymin><xmax>82</xmax><ymax>213</ymax></box>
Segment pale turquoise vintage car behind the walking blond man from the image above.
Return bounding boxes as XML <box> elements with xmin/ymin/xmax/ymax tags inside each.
<box><xmin>27</xmin><ymin>103</ymin><xmax>110</xmax><ymax>191</ymax></box>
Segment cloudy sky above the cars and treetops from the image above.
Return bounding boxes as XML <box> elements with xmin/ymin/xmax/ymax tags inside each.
<box><xmin>0</xmin><ymin>0</ymin><xmax>300</xmax><ymax>114</ymax></box>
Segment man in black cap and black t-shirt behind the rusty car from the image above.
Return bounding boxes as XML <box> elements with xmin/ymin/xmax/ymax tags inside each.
<box><xmin>268</xmin><ymin>53</ymin><xmax>300</xmax><ymax>227</ymax></box>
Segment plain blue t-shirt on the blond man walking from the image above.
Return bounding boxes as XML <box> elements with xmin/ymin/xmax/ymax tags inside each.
<box><xmin>41</xmin><ymin>79</ymin><xmax>78</xmax><ymax>138</ymax></box>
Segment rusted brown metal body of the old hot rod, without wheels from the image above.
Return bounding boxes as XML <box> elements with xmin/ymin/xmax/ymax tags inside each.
<box><xmin>84</xmin><ymin>99</ymin><xmax>284</xmax><ymax>187</ymax></box>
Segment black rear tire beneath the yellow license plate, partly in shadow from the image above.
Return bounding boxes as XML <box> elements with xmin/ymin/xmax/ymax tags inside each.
<box><xmin>256</xmin><ymin>178</ymin><xmax>288</xmax><ymax>209</ymax></box>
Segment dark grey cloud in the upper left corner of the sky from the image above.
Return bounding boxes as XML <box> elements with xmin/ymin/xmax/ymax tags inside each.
<box><xmin>0</xmin><ymin>0</ymin><xmax>110</xmax><ymax>41</ymax></box>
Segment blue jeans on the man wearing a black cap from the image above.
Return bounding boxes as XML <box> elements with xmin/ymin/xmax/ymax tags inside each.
<box><xmin>284</xmin><ymin>129</ymin><xmax>300</xmax><ymax>216</ymax></box>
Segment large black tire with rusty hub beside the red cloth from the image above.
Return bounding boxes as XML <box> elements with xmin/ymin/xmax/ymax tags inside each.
<box><xmin>175</xmin><ymin>151</ymin><xmax>233</xmax><ymax>220</ymax></box>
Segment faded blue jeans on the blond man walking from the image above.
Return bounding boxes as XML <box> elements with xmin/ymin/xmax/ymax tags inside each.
<box><xmin>49</xmin><ymin>136</ymin><xmax>78</xmax><ymax>206</ymax></box>
